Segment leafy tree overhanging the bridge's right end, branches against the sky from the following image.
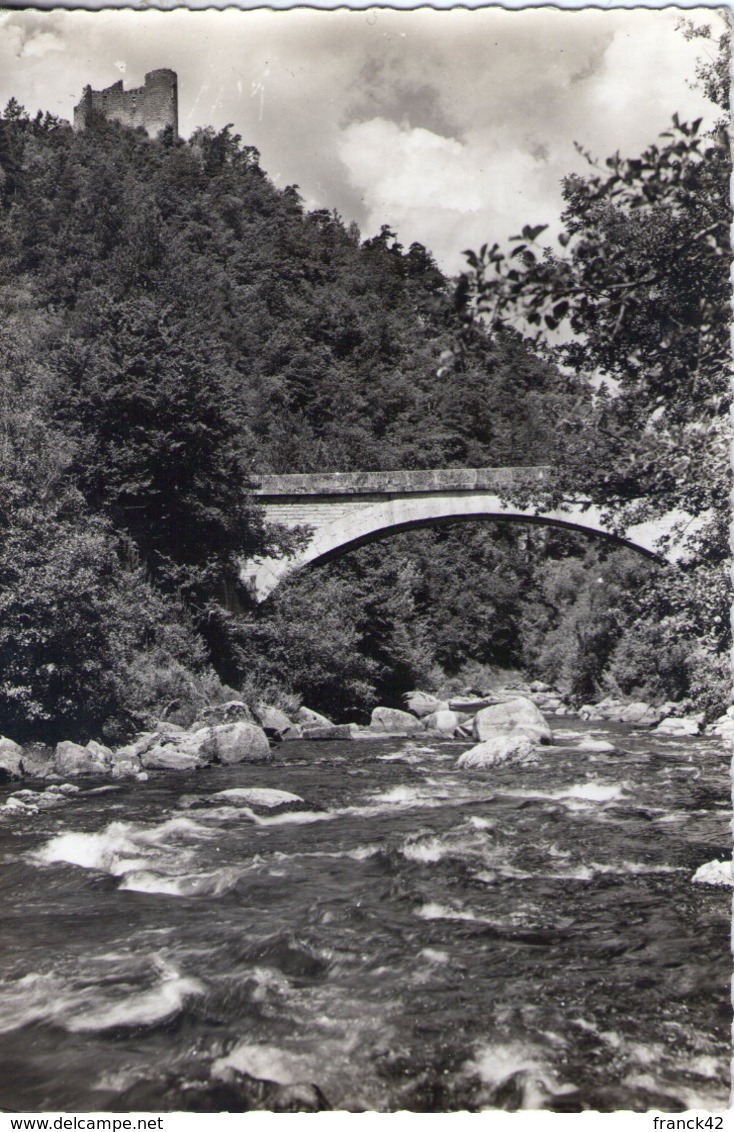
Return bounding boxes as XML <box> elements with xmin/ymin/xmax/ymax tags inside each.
<box><xmin>460</xmin><ymin>29</ymin><xmax>731</xmax><ymax>710</ymax></box>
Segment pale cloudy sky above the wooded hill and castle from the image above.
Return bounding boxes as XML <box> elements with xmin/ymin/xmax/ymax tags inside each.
<box><xmin>0</xmin><ymin>8</ymin><xmax>719</xmax><ymax>272</ymax></box>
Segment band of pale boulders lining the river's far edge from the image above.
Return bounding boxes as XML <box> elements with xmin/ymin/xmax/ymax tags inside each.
<box><xmin>0</xmin><ymin>681</ymin><xmax>734</xmax><ymax>782</ymax></box>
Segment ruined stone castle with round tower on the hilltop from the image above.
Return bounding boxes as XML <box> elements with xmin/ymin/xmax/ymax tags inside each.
<box><xmin>74</xmin><ymin>68</ymin><xmax>178</xmax><ymax>138</ymax></box>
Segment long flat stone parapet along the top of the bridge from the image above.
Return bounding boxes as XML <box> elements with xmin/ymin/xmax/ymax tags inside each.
<box><xmin>254</xmin><ymin>466</ymin><xmax>551</xmax><ymax>498</ymax></box>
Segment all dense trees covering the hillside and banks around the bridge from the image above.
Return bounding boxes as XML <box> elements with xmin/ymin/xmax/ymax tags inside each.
<box><xmin>0</xmin><ymin>26</ymin><xmax>729</xmax><ymax>741</ymax></box>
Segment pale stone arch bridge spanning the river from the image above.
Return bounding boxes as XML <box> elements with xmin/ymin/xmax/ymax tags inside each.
<box><xmin>242</xmin><ymin>468</ymin><xmax>672</xmax><ymax>601</ymax></box>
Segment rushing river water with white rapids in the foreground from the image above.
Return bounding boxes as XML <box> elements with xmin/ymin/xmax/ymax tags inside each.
<box><xmin>0</xmin><ymin>717</ymin><xmax>731</xmax><ymax>1112</ymax></box>
